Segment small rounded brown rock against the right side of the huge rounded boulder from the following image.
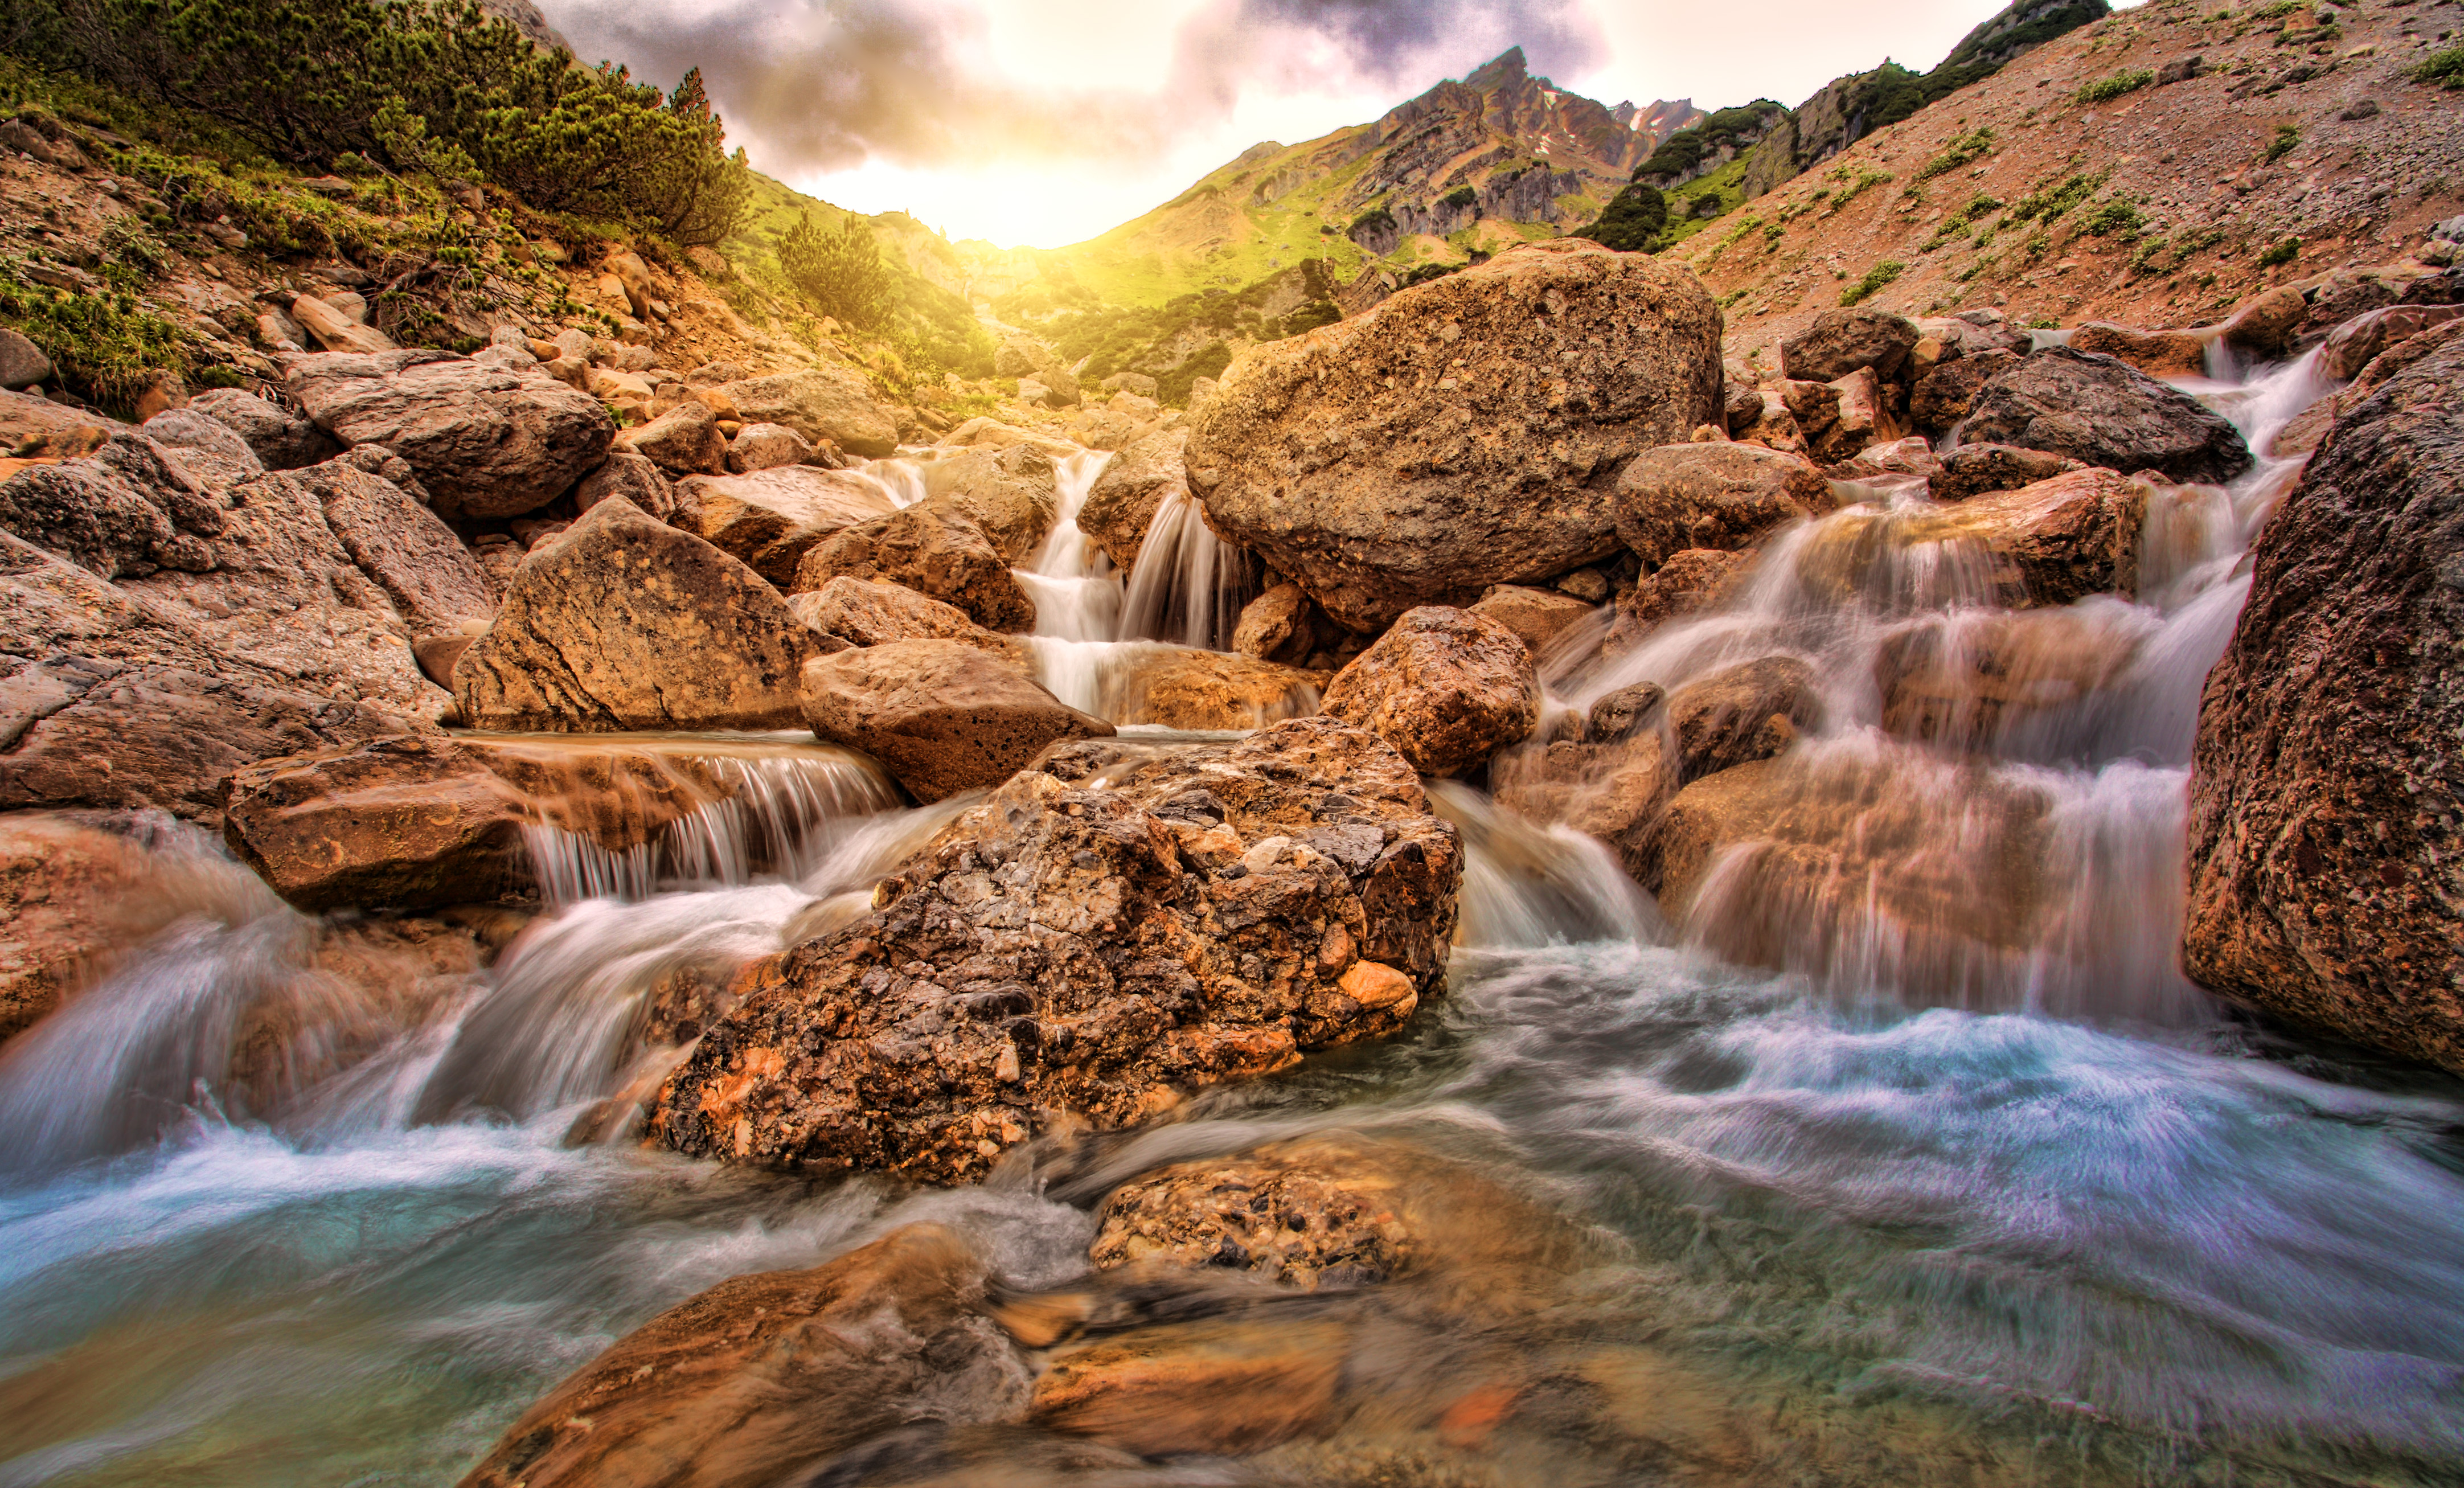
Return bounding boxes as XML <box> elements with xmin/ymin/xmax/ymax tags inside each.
<box><xmin>1614</xmin><ymin>444</ymin><xmax>1831</xmax><ymax>569</ymax></box>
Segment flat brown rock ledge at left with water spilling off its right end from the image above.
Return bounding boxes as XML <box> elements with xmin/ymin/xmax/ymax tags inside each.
<box><xmin>222</xmin><ymin>734</ymin><xmax>727</xmax><ymax>914</ymax></box>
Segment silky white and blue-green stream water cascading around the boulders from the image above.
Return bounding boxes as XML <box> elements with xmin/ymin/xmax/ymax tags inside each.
<box><xmin>0</xmin><ymin>354</ymin><xmax>2464</xmax><ymax>1488</ymax></box>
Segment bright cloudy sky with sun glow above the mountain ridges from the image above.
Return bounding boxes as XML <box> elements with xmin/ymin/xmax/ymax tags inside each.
<box><xmin>537</xmin><ymin>0</ymin><xmax>2099</xmax><ymax>249</ymax></box>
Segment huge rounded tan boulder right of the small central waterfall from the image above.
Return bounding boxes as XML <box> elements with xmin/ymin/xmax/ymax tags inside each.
<box><xmin>1188</xmin><ymin>239</ymin><xmax>1723</xmax><ymax>633</ymax></box>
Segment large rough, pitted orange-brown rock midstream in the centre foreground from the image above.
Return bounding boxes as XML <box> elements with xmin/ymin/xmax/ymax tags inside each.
<box><xmin>655</xmin><ymin>719</ymin><xmax>1461</xmax><ymax>1183</ymax></box>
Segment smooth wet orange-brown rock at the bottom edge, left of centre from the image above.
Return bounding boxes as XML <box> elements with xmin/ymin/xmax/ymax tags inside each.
<box><xmin>461</xmin><ymin>1224</ymin><xmax>1027</xmax><ymax>1488</ymax></box>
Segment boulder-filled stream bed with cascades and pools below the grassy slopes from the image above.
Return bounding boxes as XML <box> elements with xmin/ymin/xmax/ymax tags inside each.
<box><xmin>0</xmin><ymin>29</ymin><xmax>2464</xmax><ymax>1488</ymax></box>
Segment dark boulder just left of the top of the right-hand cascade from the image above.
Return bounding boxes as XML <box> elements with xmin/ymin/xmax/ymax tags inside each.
<box><xmin>1959</xmin><ymin>347</ymin><xmax>2252</xmax><ymax>483</ymax></box>
